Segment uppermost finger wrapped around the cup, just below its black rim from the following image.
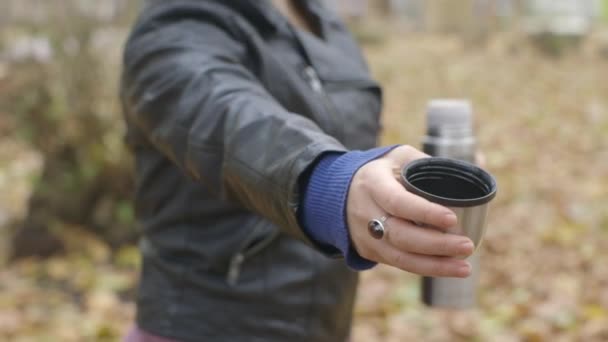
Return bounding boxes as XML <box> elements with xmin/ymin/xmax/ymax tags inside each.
<box><xmin>370</xmin><ymin>177</ymin><xmax>457</xmax><ymax>229</ymax></box>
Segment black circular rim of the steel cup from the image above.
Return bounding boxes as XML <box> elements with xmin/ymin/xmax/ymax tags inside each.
<box><xmin>401</xmin><ymin>157</ymin><xmax>498</xmax><ymax>208</ymax></box>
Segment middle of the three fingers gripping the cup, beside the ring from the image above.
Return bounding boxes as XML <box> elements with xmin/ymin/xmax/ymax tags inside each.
<box><xmin>385</xmin><ymin>217</ymin><xmax>475</xmax><ymax>257</ymax></box>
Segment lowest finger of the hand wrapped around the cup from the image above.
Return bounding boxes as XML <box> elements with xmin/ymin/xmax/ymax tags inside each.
<box><xmin>381</xmin><ymin>245</ymin><xmax>471</xmax><ymax>278</ymax></box>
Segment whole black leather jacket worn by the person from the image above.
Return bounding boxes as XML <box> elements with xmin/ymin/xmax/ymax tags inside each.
<box><xmin>121</xmin><ymin>0</ymin><xmax>381</xmax><ymax>342</ymax></box>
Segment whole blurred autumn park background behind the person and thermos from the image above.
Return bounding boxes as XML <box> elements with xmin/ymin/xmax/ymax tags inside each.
<box><xmin>0</xmin><ymin>0</ymin><xmax>608</xmax><ymax>341</ymax></box>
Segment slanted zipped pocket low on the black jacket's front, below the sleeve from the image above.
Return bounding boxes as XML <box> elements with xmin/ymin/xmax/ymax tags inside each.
<box><xmin>226</xmin><ymin>218</ymin><xmax>280</xmax><ymax>286</ymax></box>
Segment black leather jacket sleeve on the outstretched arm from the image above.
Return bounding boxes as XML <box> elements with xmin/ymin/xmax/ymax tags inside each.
<box><xmin>122</xmin><ymin>2</ymin><xmax>345</xmax><ymax>244</ymax></box>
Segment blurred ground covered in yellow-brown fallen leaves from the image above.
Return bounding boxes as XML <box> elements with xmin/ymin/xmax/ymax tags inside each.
<box><xmin>0</xmin><ymin>28</ymin><xmax>608</xmax><ymax>342</ymax></box>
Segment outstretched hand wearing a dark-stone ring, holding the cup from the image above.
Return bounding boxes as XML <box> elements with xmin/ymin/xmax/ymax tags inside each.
<box><xmin>346</xmin><ymin>146</ymin><xmax>474</xmax><ymax>278</ymax></box>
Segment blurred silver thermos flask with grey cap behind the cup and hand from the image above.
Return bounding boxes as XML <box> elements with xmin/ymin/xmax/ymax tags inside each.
<box><xmin>422</xmin><ymin>100</ymin><xmax>479</xmax><ymax>309</ymax></box>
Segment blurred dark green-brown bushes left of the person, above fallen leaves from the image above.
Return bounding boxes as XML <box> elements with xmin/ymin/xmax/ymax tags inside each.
<box><xmin>0</xmin><ymin>1</ymin><xmax>136</xmax><ymax>257</ymax></box>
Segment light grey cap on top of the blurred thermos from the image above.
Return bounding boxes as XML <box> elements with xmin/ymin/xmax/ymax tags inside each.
<box><xmin>427</xmin><ymin>99</ymin><xmax>473</xmax><ymax>130</ymax></box>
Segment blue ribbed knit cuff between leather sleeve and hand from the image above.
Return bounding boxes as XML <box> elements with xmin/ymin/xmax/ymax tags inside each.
<box><xmin>300</xmin><ymin>145</ymin><xmax>399</xmax><ymax>271</ymax></box>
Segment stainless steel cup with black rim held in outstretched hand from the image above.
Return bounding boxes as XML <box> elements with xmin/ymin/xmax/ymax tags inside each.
<box><xmin>401</xmin><ymin>157</ymin><xmax>497</xmax><ymax>248</ymax></box>
